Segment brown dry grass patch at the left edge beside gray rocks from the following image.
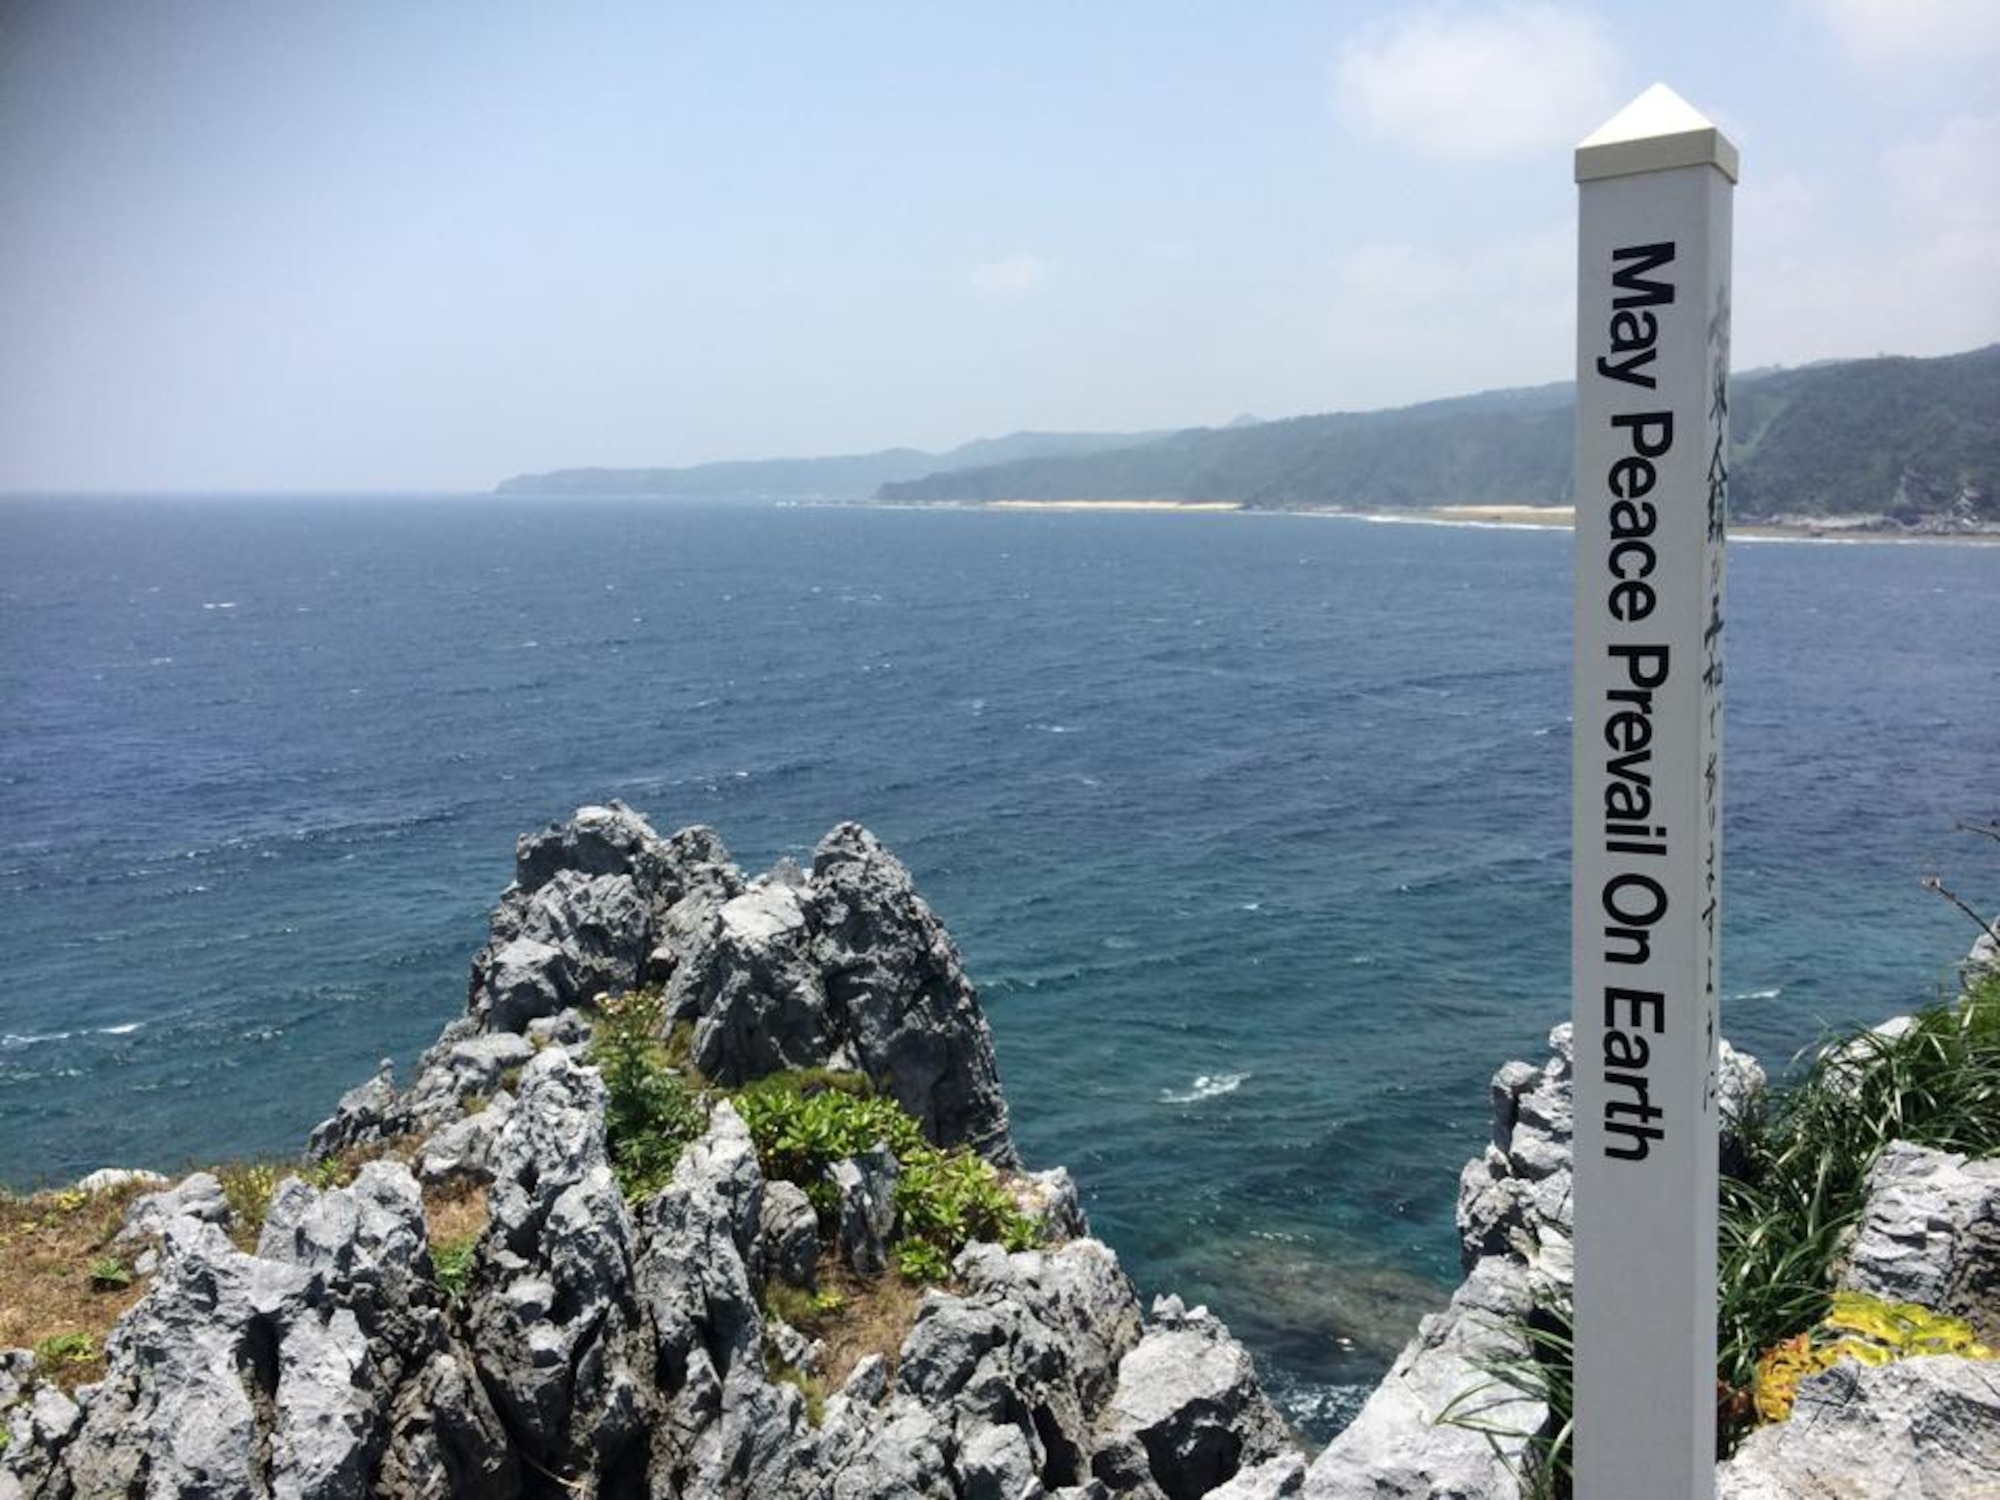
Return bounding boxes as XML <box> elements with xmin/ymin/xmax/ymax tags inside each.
<box><xmin>0</xmin><ymin>1182</ymin><xmax>154</xmax><ymax>1390</ymax></box>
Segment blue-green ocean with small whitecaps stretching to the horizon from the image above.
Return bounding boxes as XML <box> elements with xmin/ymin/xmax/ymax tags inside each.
<box><xmin>0</xmin><ymin>498</ymin><xmax>2000</xmax><ymax>1432</ymax></box>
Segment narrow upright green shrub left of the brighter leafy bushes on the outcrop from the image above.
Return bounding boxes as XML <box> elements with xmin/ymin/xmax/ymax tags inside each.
<box><xmin>590</xmin><ymin>990</ymin><xmax>704</xmax><ymax>1200</ymax></box>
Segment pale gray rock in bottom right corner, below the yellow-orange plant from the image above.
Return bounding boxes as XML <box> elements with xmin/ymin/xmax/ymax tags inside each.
<box><xmin>1716</xmin><ymin>1356</ymin><xmax>2000</xmax><ymax>1500</ymax></box>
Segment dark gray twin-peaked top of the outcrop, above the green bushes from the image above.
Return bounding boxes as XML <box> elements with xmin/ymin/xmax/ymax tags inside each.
<box><xmin>312</xmin><ymin>802</ymin><xmax>1018</xmax><ymax>1170</ymax></box>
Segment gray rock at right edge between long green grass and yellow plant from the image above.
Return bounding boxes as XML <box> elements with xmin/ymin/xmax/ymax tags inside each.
<box><xmin>1840</xmin><ymin>1140</ymin><xmax>2000</xmax><ymax>1342</ymax></box>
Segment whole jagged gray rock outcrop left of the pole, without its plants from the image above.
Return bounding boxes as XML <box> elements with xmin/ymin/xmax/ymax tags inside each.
<box><xmin>0</xmin><ymin>806</ymin><xmax>1280</xmax><ymax>1500</ymax></box>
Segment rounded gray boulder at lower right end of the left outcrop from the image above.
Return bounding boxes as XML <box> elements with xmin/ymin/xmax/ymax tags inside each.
<box><xmin>1098</xmin><ymin>1296</ymin><xmax>1292</xmax><ymax>1500</ymax></box>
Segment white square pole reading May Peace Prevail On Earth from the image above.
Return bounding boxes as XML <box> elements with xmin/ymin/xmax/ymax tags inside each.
<box><xmin>1570</xmin><ymin>84</ymin><xmax>1736</xmax><ymax>1500</ymax></box>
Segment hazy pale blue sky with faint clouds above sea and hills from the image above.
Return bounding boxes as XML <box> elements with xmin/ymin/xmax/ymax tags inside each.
<box><xmin>0</xmin><ymin>0</ymin><xmax>2000</xmax><ymax>490</ymax></box>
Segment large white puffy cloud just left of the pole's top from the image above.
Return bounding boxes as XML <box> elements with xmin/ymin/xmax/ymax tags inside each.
<box><xmin>1334</xmin><ymin>4</ymin><xmax>1618</xmax><ymax>158</ymax></box>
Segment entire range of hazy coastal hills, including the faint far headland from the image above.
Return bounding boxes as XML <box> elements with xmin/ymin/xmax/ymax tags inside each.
<box><xmin>498</xmin><ymin>344</ymin><xmax>2000</xmax><ymax>526</ymax></box>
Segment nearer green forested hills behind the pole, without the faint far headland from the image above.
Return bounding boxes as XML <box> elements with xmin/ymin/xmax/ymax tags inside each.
<box><xmin>878</xmin><ymin>344</ymin><xmax>2000</xmax><ymax>520</ymax></box>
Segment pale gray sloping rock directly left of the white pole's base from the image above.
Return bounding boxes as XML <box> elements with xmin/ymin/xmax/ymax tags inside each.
<box><xmin>1304</xmin><ymin>1256</ymin><xmax>1548</xmax><ymax>1500</ymax></box>
